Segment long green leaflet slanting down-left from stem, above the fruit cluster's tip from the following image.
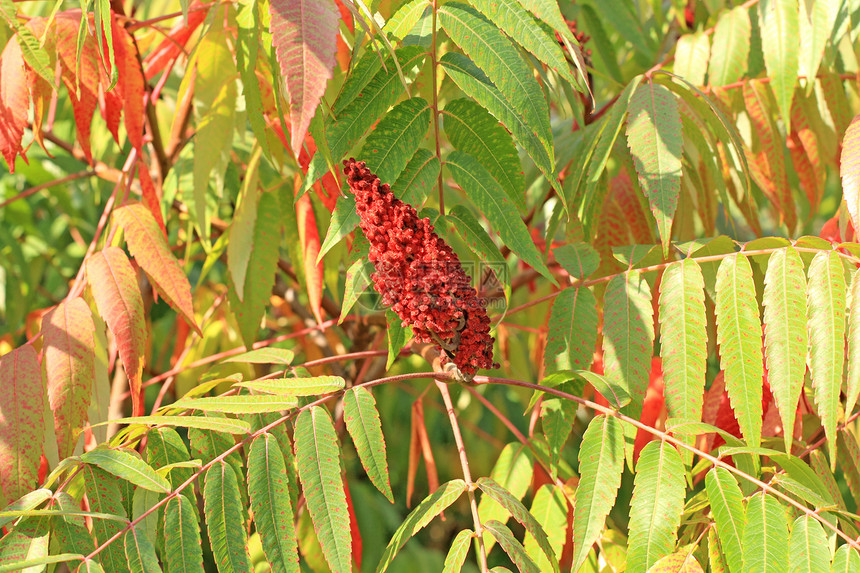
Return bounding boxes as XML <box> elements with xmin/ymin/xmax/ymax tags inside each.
<box><xmin>304</xmin><ymin>46</ymin><xmax>425</xmax><ymax>193</ymax></box>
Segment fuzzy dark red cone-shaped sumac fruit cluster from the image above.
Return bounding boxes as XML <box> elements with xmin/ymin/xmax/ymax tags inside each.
<box><xmin>343</xmin><ymin>158</ymin><xmax>498</xmax><ymax>376</ymax></box>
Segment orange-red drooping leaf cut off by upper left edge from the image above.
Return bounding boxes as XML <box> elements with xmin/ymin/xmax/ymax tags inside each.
<box><xmin>0</xmin><ymin>38</ymin><xmax>30</xmax><ymax>169</ymax></box>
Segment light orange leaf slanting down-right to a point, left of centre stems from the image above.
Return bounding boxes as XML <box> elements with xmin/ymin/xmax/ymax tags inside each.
<box><xmin>114</xmin><ymin>203</ymin><xmax>200</xmax><ymax>333</ymax></box>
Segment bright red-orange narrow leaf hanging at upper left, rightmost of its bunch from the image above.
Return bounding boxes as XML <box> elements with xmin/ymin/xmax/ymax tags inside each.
<box><xmin>111</xmin><ymin>19</ymin><xmax>146</xmax><ymax>154</ymax></box>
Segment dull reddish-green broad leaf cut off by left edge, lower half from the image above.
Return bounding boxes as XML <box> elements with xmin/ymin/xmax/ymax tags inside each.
<box><xmin>0</xmin><ymin>344</ymin><xmax>45</xmax><ymax>506</ymax></box>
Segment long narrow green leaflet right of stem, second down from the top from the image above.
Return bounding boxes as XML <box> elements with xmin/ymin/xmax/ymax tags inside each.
<box><xmin>439</xmin><ymin>52</ymin><xmax>555</xmax><ymax>183</ymax></box>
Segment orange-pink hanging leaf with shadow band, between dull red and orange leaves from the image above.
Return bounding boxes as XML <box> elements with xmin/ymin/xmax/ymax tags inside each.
<box><xmin>42</xmin><ymin>297</ymin><xmax>95</xmax><ymax>459</ymax></box>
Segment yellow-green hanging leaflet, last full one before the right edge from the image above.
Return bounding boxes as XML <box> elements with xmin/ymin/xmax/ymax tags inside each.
<box><xmin>807</xmin><ymin>251</ymin><xmax>846</xmax><ymax>470</ymax></box>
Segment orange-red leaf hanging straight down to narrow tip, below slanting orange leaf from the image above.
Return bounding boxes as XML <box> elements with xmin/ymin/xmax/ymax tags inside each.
<box><xmin>87</xmin><ymin>247</ymin><xmax>146</xmax><ymax>416</ymax></box>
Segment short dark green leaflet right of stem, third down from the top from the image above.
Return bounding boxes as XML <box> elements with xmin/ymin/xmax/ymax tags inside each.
<box><xmin>442</xmin><ymin>98</ymin><xmax>526</xmax><ymax>213</ymax></box>
